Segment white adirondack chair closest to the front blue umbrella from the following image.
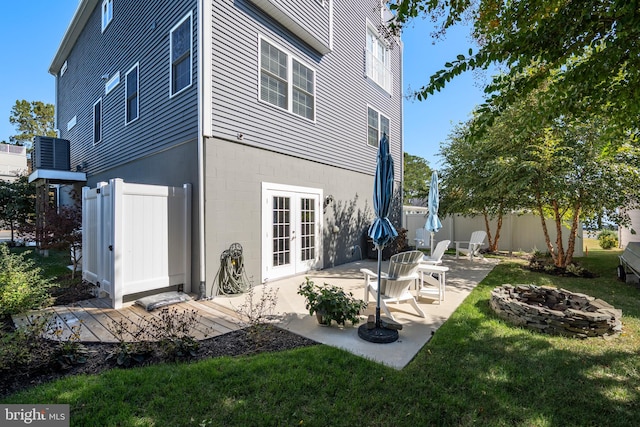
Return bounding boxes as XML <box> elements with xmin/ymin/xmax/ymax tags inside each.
<box><xmin>360</xmin><ymin>251</ymin><xmax>424</xmax><ymax>320</ymax></box>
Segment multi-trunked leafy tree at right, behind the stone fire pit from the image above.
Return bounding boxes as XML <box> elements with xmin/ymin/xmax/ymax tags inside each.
<box><xmin>520</xmin><ymin>117</ymin><xmax>640</xmax><ymax>267</ymax></box>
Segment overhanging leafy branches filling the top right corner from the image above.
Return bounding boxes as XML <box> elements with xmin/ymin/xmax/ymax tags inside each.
<box><xmin>389</xmin><ymin>0</ymin><xmax>640</xmax><ymax>132</ymax></box>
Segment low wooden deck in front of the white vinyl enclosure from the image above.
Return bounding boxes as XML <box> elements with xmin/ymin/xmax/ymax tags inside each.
<box><xmin>13</xmin><ymin>298</ymin><xmax>242</xmax><ymax>342</ymax></box>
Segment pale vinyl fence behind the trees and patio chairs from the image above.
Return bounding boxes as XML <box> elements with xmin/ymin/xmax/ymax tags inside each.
<box><xmin>402</xmin><ymin>206</ymin><xmax>584</xmax><ymax>256</ymax></box>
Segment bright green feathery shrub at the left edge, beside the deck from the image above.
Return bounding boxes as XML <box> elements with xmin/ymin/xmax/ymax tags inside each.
<box><xmin>0</xmin><ymin>245</ymin><xmax>54</xmax><ymax>315</ymax></box>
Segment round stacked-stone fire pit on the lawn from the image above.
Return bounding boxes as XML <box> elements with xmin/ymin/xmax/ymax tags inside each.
<box><xmin>489</xmin><ymin>285</ymin><xmax>622</xmax><ymax>338</ymax></box>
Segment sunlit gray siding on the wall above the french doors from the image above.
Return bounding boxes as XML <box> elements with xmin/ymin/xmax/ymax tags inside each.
<box><xmin>211</xmin><ymin>0</ymin><xmax>402</xmax><ymax>180</ymax></box>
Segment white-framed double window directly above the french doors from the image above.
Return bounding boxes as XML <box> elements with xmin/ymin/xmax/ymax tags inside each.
<box><xmin>260</xmin><ymin>38</ymin><xmax>315</xmax><ymax>120</ymax></box>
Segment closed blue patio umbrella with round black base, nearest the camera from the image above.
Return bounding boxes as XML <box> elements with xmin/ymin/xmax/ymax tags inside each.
<box><xmin>358</xmin><ymin>134</ymin><xmax>398</xmax><ymax>342</ymax></box>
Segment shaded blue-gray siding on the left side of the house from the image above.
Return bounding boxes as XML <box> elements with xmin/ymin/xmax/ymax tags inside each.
<box><xmin>56</xmin><ymin>0</ymin><xmax>198</xmax><ymax>179</ymax></box>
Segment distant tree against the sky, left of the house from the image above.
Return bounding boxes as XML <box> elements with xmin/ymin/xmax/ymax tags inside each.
<box><xmin>9</xmin><ymin>99</ymin><xmax>57</xmax><ymax>145</ymax></box>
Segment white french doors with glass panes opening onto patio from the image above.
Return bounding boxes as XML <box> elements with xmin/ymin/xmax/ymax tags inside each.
<box><xmin>262</xmin><ymin>183</ymin><xmax>322</xmax><ymax>282</ymax></box>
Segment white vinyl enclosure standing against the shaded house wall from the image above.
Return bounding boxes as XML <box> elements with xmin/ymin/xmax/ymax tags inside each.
<box><xmin>82</xmin><ymin>178</ymin><xmax>191</xmax><ymax>308</ymax></box>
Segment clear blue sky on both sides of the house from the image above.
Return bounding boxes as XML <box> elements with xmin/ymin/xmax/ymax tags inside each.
<box><xmin>0</xmin><ymin>0</ymin><xmax>482</xmax><ymax>167</ymax></box>
